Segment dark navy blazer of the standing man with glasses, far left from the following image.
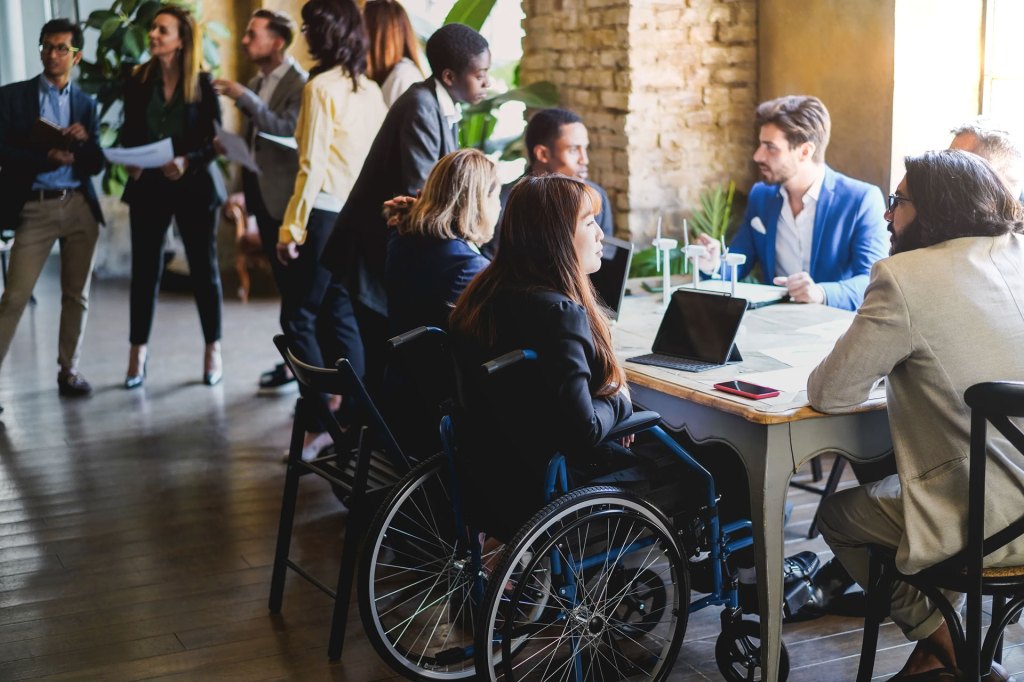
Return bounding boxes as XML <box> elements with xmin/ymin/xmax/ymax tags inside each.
<box><xmin>0</xmin><ymin>76</ymin><xmax>103</xmax><ymax>229</ymax></box>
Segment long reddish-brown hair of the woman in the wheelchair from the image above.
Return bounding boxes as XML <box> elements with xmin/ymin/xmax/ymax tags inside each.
<box><xmin>450</xmin><ymin>173</ymin><xmax>626</xmax><ymax>396</ymax></box>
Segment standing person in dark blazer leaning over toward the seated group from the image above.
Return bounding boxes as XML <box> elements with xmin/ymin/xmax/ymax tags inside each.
<box><xmin>322</xmin><ymin>24</ymin><xmax>490</xmax><ymax>390</ymax></box>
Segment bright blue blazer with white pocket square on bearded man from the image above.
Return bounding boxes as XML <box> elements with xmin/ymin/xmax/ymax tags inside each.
<box><xmin>729</xmin><ymin>166</ymin><xmax>889</xmax><ymax>310</ymax></box>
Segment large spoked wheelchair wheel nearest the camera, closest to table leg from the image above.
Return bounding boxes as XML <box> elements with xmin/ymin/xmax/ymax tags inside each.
<box><xmin>475</xmin><ymin>486</ymin><xmax>689</xmax><ymax>682</ymax></box>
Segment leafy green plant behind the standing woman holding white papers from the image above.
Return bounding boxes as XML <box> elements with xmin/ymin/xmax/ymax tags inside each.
<box><xmin>79</xmin><ymin>0</ymin><xmax>231</xmax><ymax>196</ymax></box>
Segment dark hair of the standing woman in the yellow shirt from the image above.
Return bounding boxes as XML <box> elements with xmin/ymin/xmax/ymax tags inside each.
<box><xmin>302</xmin><ymin>0</ymin><xmax>367</xmax><ymax>89</ymax></box>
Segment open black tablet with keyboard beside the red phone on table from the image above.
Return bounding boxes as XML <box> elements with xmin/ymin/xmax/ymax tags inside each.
<box><xmin>627</xmin><ymin>289</ymin><xmax>746</xmax><ymax>372</ymax></box>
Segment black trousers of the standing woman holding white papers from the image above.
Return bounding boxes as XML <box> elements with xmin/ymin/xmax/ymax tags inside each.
<box><xmin>129</xmin><ymin>195</ymin><xmax>224</xmax><ymax>345</ymax></box>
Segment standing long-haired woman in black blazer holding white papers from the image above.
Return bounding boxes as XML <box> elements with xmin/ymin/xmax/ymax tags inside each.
<box><xmin>121</xmin><ymin>5</ymin><xmax>223</xmax><ymax>388</ymax></box>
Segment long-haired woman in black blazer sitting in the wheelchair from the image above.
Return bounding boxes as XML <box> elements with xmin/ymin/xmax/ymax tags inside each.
<box><xmin>450</xmin><ymin>174</ymin><xmax>633</xmax><ymax>541</ymax></box>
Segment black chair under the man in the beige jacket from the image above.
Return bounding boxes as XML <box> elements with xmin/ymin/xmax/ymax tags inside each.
<box><xmin>857</xmin><ymin>382</ymin><xmax>1024</xmax><ymax>682</ymax></box>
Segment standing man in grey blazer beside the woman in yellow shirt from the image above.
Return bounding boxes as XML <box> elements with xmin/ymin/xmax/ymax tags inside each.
<box><xmin>214</xmin><ymin>9</ymin><xmax>308</xmax><ymax>393</ymax></box>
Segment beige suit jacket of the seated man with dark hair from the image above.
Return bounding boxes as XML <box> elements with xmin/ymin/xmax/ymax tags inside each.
<box><xmin>807</xmin><ymin>235</ymin><xmax>1024</xmax><ymax>573</ymax></box>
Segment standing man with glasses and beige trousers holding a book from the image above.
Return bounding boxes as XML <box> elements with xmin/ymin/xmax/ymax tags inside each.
<box><xmin>0</xmin><ymin>18</ymin><xmax>103</xmax><ymax>409</ymax></box>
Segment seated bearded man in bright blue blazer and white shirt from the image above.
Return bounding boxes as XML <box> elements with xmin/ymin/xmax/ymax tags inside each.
<box><xmin>700</xmin><ymin>96</ymin><xmax>889</xmax><ymax>310</ymax></box>
